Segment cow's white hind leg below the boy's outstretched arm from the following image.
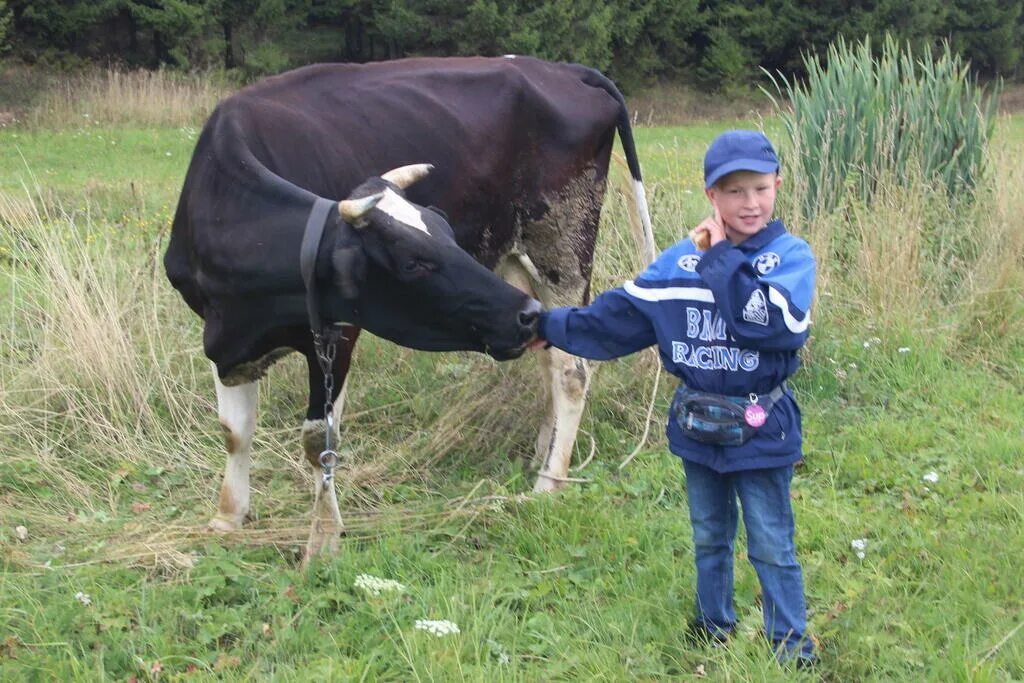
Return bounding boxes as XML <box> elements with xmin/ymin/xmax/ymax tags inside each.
<box><xmin>534</xmin><ymin>347</ymin><xmax>592</xmax><ymax>492</ymax></box>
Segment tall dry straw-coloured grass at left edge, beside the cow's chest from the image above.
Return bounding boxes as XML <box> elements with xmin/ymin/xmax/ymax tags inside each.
<box><xmin>0</xmin><ymin>194</ymin><xmax>209</xmax><ymax>518</ymax></box>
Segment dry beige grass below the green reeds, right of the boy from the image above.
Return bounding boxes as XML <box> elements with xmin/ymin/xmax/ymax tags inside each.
<box><xmin>781</xmin><ymin>124</ymin><xmax>1024</xmax><ymax>353</ymax></box>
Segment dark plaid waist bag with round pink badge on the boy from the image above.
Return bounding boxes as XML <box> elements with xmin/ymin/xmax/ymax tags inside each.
<box><xmin>669</xmin><ymin>383</ymin><xmax>785</xmax><ymax>445</ymax></box>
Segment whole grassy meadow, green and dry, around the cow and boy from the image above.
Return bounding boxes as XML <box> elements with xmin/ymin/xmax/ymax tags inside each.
<box><xmin>0</xmin><ymin>69</ymin><xmax>1024</xmax><ymax>681</ymax></box>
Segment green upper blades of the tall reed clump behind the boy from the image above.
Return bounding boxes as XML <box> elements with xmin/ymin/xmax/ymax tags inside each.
<box><xmin>766</xmin><ymin>36</ymin><xmax>998</xmax><ymax>222</ymax></box>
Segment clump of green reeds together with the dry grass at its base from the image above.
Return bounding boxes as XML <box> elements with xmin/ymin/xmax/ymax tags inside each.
<box><xmin>775</xmin><ymin>37</ymin><xmax>1024</xmax><ymax>360</ymax></box>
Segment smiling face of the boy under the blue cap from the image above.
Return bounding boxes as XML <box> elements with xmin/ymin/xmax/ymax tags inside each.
<box><xmin>705</xmin><ymin>171</ymin><xmax>782</xmax><ymax>243</ymax></box>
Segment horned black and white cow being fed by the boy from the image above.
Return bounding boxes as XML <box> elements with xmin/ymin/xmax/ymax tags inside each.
<box><xmin>165</xmin><ymin>57</ymin><xmax>653</xmax><ymax>557</ymax></box>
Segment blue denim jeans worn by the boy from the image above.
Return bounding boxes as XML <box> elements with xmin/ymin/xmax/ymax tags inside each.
<box><xmin>683</xmin><ymin>460</ymin><xmax>814</xmax><ymax>658</ymax></box>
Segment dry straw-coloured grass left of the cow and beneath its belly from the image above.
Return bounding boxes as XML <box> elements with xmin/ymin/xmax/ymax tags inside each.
<box><xmin>0</xmin><ymin>178</ymin><xmax>655</xmax><ymax>557</ymax></box>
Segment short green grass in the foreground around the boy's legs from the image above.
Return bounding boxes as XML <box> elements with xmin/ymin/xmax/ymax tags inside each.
<box><xmin>0</xmin><ymin>366</ymin><xmax>1024</xmax><ymax>680</ymax></box>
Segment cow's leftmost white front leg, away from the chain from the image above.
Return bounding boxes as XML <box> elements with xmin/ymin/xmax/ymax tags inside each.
<box><xmin>210</xmin><ymin>367</ymin><xmax>257</xmax><ymax>531</ymax></box>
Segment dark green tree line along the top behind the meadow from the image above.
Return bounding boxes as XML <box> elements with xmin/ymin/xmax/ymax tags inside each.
<box><xmin>0</xmin><ymin>0</ymin><xmax>1024</xmax><ymax>90</ymax></box>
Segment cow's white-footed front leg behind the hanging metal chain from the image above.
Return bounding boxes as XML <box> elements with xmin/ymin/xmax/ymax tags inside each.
<box><xmin>302</xmin><ymin>327</ymin><xmax>359</xmax><ymax>564</ymax></box>
